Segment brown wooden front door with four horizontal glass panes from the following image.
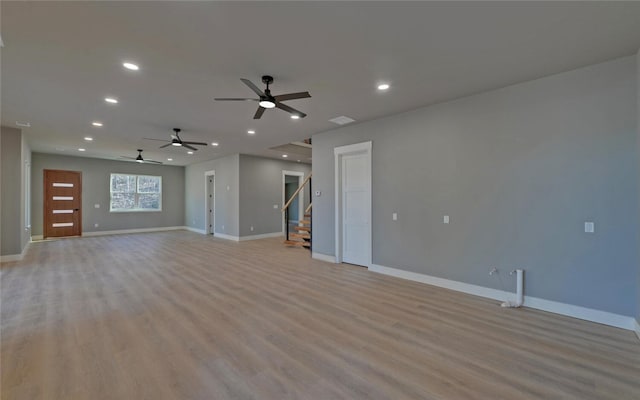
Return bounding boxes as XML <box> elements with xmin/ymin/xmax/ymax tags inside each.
<box><xmin>43</xmin><ymin>169</ymin><xmax>82</xmax><ymax>238</ymax></box>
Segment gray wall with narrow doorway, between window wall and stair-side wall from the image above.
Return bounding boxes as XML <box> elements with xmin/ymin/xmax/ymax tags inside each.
<box><xmin>185</xmin><ymin>154</ymin><xmax>239</xmax><ymax>236</ymax></box>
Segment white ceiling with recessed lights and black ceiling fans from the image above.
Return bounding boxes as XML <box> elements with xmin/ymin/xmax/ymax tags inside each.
<box><xmin>0</xmin><ymin>2</ymin><xmax>640</xmax><ymax>165</ymax></box>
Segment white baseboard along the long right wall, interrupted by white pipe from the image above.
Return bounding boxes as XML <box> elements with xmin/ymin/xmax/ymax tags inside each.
<box><xmin>369</xmin><ymin>264</ymin><xmax>637</xmax><ymax>330</ymax></box>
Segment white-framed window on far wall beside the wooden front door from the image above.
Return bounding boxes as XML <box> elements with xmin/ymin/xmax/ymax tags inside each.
<box><xmin>109</xmin><ymin>174</ymin><xmax>162</xmax><ymax>212</ymax></box>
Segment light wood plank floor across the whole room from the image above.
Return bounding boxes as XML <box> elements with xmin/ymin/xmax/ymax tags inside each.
<box><xmin>1</xmin><ymin>232</ymin><xmax>640</xmax><ymax>400</ymax></box>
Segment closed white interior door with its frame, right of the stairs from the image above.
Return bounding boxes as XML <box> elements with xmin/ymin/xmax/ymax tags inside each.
<box><xmin>336</xmin><ymin>144</ymin><xmax>371</xmax><ymax>267</ymax></box>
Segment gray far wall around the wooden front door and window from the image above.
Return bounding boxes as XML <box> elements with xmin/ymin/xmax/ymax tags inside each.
<box><xmin>31</xmin><ymin>153</ymin><xmax>185</xmax><ymax>235</ymax></box>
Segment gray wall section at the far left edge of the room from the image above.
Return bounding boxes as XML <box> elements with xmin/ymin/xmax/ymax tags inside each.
<box><xmin>0</xmin><ymin>126</ymin><xmax>31</xmax><ymax>255</ymax></box>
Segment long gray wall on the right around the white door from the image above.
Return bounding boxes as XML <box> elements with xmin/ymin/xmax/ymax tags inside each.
<box><xmin>313</xmin><ymin>57</ymin><xmax>638</xmax><ymax>316</ymax></box>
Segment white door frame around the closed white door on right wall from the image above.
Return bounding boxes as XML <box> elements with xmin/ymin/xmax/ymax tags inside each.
<box><xmin>333</xmin><ymin>141</ymin><xmax>373</xmax><ymax>268</ymax></box>
